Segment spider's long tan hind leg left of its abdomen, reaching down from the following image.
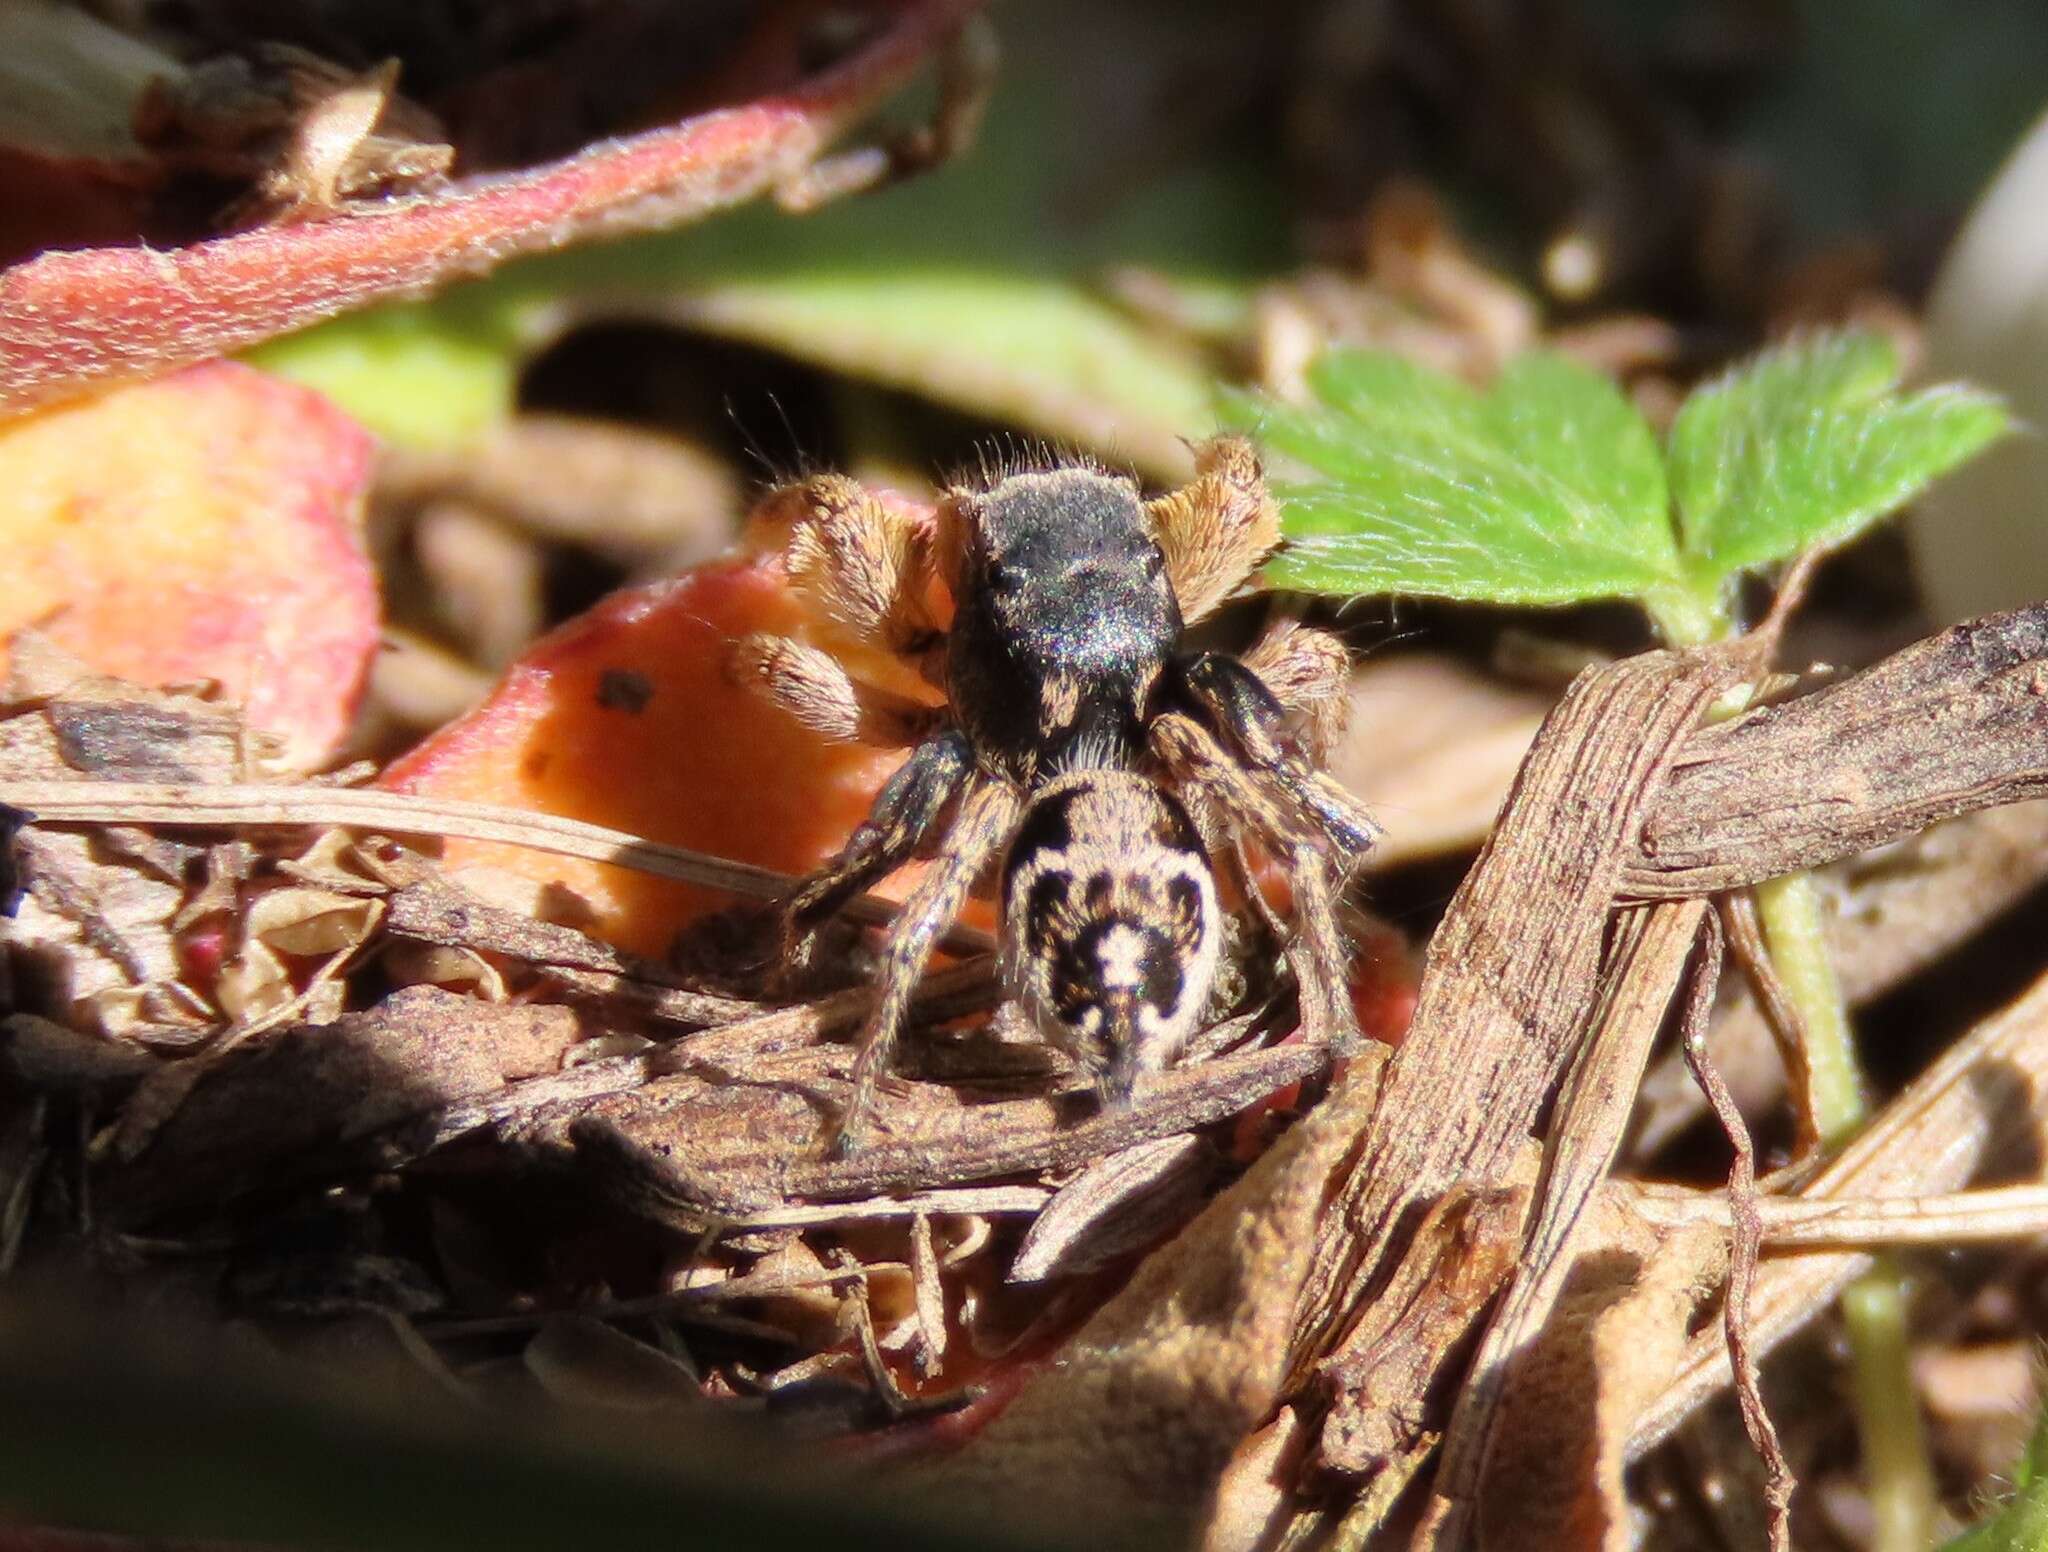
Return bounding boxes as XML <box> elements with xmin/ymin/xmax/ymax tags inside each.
<box><xmin>834</xmin><ymin>778</ymin><xmax>1024</xmax><ymax>1153</ymax></box>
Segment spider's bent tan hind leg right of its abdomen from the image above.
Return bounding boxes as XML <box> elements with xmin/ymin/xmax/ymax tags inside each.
<box><xmin>1151</xmin><ymin>713</ymin><xmax>1362</xmax><ymax>1057</ymax></box>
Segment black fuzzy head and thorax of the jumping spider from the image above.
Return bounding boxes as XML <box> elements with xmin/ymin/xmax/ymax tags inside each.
<box><xmin>946</xmin><ymin>469</ymin><xmax>1182</xmax><ymax>782</ymax></box>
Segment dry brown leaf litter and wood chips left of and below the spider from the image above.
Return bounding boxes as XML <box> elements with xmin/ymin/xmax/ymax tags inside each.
<box><xmin>0</xmin><ymin>626</ymin><xmax>1321</xmax><ymax>1441</ymax></box>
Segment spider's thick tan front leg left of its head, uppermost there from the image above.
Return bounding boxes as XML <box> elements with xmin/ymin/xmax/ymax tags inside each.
<box><xmin>770</xmin><ymin>475</ymin><xmax>938</xmax><ymax>657</ymax></box>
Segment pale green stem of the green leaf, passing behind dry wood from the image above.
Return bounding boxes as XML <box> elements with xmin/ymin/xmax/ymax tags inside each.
<box><xmin>1653</xmin><ymin>598</ymin><xmax>1939</xmax><ymax>1552</ymax></box>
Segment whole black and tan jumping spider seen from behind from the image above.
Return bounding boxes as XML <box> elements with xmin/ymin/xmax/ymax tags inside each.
<box><xmin>731</xmin><ymin>438</ymin><xmax>1376</xmax><ymax>1143</ymax></box>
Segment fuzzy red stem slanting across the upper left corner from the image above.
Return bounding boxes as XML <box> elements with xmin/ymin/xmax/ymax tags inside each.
<box><xmin>0</xmin><ymin>0</ymin><xmax>979</xmax><ymax>414</ymax></box>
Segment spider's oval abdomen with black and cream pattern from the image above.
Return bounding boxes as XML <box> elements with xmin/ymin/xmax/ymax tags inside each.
<box><xmin>1004</xmin><ymin>770</ymin><xmax>1221</xmax><ymax>1102</ymax></box>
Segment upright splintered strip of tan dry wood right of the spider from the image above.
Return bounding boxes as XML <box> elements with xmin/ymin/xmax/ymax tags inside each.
<box><xmin>1294</xmin><ymin>653</ymin><xmax>1737</xmax><ymax>1449</ymax></box>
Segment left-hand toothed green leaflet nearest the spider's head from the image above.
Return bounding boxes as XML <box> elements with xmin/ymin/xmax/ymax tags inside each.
<box><xmin>1225</xmin><ymin>352</ymin><xmax>1681</xmax><ymax>604</ymax></box>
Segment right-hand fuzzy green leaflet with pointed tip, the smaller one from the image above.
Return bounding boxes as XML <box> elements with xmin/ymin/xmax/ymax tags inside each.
<box><xmin>1669</xmin><ymin>334</ymin><xmax>2007</xmax><ymax>590</ymax></box>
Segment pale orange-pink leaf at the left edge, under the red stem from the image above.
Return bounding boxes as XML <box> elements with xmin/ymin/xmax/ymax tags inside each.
<box><xmin>0</xmin><ymin>362</ymin><xmax>379</xmax><ymax>768</ymax></box>
